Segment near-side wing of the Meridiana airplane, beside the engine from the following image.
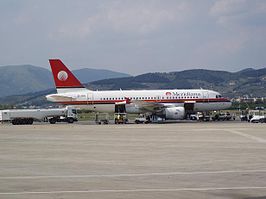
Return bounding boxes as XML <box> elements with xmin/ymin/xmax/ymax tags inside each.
<box><xmin>131</xmin><ymin>100</ymin><xmax>174</xmax><ymax>112</ymax></box>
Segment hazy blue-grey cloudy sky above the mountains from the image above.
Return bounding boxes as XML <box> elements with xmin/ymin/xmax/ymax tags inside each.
<box><xmin>0</xmin><ymin>0</ymin><xmax>266</xmax><ymax>75</ymax></box>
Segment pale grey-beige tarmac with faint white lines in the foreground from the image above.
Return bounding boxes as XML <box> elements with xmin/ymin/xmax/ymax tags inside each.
<box><xmin>0</xmin><ymin>122</ymin><xmax>266</xmax><ymax>199</ymax></box>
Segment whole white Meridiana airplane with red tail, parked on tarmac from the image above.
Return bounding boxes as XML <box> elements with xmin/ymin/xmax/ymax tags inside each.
<box><xmin>46</xmin><ymin>59</ymin><xmax>231</xmax><ymax>120</ymax></box>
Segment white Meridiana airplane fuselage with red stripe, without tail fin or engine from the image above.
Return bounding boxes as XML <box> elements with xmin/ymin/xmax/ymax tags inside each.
<box><xmin>46</xmin><ymin>88</ymin><xmax>231</xmax><ymax>113</ymax></box>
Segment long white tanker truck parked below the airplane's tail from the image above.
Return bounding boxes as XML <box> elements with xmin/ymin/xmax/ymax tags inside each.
<box><xmin>0</xmin><ymin>106</ymin><xmax>77</xmax><ymax>125</ymax></box>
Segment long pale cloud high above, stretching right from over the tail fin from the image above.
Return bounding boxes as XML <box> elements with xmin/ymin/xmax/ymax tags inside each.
<box><xmin>51</xmin><ymin>1</ymin><xmax>190</xmax><ymax>38</ymax></box>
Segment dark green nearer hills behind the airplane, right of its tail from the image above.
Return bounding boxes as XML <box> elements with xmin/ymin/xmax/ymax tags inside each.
<box><xmin>88</xmin><ymin>68</ymin><xmax>266</xmax><ymax>97</ymax></box>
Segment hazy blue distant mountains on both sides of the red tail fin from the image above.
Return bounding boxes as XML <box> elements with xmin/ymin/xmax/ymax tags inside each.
<box><xmin>0</xmin><ymin>65</ymin><xmax>129</xmax><ymax>97</ymax></box>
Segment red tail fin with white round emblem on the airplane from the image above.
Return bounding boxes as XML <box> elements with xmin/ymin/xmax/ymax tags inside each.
<box><xmin>49</xmin><ymin>59</ymin><xmax>84</xmax><ymax>88</ymax></box>
